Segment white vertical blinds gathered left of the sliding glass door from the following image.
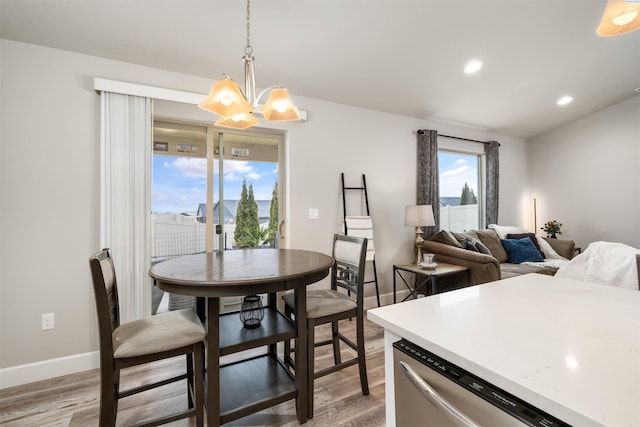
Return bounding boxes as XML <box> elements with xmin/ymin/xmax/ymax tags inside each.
<box><xmin>100</xmin><ymin>92</ymin><xmax>152</xmax><ymax>322</ymax></box>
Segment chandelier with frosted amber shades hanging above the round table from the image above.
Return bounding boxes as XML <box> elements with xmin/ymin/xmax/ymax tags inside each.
<box><xmin>198</xmin><ymin>0</ymin><xmax>300</xmax><ymax>129</ymax></box>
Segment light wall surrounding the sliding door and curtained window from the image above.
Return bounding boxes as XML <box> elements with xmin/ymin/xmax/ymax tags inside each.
<box><xmin>0</xmin><ymin>40</ymin><xmax>530</xmax><ymax>387</ymax></box>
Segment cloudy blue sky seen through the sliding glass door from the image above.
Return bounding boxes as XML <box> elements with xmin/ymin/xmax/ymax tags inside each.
<box><xmin>151</xmin><ymin>156</ymin><xmax>278</xmax><ymax>214</ymax></box>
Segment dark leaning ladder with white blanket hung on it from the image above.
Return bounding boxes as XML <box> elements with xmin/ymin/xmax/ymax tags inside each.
<box><xmin>341</xmin><ymin>173</ymin><xmax>380</xmax><ymax>307</ymax></box>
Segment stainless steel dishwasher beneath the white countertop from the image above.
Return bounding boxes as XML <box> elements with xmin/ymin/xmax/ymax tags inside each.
<box><xmin>393</xmin><ymin>339</ymin><xmax>569</xmax><ymax>427</ymax></box>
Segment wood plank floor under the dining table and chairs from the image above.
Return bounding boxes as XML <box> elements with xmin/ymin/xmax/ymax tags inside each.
<box><xmin>0</xmin><ymin>319</ymin><xmax>385</xmax><ymax>427</ymax></box>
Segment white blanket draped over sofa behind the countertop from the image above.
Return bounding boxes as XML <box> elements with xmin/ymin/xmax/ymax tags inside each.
<box><xmin>555</xmin><ymin>242</ymin><xmax>640</xmax><ymax>290</ymax></box>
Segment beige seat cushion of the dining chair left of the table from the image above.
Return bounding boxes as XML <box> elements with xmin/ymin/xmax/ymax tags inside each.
<box><xmin>112</xmin><ymin>309</ymin><xmax>205</xmax><ymax>359</ymax></box>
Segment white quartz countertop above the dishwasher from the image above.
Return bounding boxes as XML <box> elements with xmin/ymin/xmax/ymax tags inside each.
<box><xmin>367</xmin><ymin>274</ymin><xmax>640</xmax><ymax>427</ymax></box>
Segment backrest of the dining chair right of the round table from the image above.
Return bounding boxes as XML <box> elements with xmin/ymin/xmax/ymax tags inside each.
<box><xmin>331</xmin><ymin>234</ymin><xmax>367</xmax><ymax>298</ymax></box>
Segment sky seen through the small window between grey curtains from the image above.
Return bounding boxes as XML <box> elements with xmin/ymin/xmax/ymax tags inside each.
<box><xmin>438</xmin><ymin>152</ymin><xmax>478</xmax><ymax>197</ymax></box>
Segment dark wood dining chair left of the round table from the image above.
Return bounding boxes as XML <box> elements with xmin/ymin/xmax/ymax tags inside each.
<box><xmin>89</xmin><ymin>249</ymin><xmax>205</xmax><ymax>426</ymax></box>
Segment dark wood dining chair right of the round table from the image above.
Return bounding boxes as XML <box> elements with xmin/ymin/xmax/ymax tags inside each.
<box><xmin>282</xmin><ymin>234</ymin><xmax>369</xmax><ymax>418</ymax></box>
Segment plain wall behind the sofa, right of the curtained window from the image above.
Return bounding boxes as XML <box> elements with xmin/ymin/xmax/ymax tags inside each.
<box><xmin>527</xmin><ymin>95</ymin><xmax>640</xmax><ymax>250</ymax></box>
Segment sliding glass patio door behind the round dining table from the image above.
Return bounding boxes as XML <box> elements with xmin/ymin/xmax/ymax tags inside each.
<box><xmin>151</xmin><ymin>120</ymin><xmax>284</xmax><ymax>262</ymax></box>
